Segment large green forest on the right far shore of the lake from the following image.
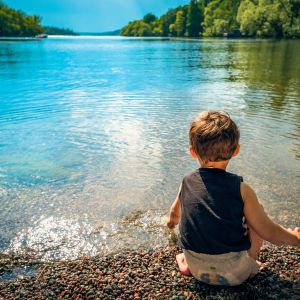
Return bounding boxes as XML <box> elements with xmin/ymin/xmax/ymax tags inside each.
<box><xmin>121</xmin><ymin>0</ymin><xmax>300</xmax><ymax>38</ymax></box>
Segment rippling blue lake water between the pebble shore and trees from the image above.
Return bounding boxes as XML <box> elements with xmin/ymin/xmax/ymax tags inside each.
<box><xmin>0</xmin><ymin>37</ymin><xmax>300</xmax><ymax>259</ymax></box>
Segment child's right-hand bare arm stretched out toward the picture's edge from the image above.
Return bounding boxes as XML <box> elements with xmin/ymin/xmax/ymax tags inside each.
<box><xmin>241</xmin><ymin>182</ymin><xmax>300</xmax><ymax>247</ymax></box>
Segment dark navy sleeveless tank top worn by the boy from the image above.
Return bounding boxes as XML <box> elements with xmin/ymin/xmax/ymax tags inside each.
<box><xmin>179</xmin><ymin>168</ymin><xmax>251</xmax><ymax>254</ymax></box>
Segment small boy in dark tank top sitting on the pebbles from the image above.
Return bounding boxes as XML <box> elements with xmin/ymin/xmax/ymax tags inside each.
<box><xmin>167</xmin><ymin>111</ymin><xmax>300</xmax><ymax>285</ymax></box>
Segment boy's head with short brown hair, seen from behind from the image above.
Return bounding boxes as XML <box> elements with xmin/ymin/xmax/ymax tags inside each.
<box><xmin>189</xmin><ymin>111</ymin><xmax>240</xmax><ymax>162</ymax></box>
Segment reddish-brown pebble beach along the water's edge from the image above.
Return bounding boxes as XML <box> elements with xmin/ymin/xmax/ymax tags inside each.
<box><xmin>0</xmin><ymin>245</ymin><xmax>300</xmax><ymax>300</ymax></box>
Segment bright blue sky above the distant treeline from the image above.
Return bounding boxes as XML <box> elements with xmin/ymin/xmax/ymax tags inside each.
<box><xmin>4</xmin><ymin>0</ymin><xmax>189</xmax><ymax>32</ymax></box>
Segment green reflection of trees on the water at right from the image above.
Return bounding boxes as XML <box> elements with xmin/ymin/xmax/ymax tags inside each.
<box><xmin>234</xmin><ymin>41</ymin><xmax>300</xmax><ymax>160</ymax></box>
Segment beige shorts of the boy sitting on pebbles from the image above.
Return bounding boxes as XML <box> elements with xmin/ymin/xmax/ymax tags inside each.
<box><xmin>183</xmin><ymin>250</ymin><xmax>259</xmax><ymax>285</ymax></box>
